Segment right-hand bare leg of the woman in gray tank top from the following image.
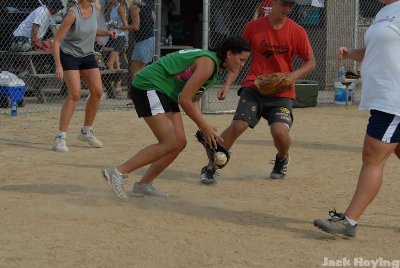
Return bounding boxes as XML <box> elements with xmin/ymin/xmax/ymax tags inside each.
<box><xmin>81</xmin><ymin>68</ymin><xmax>103</xmax><ymax>126</ymax></box>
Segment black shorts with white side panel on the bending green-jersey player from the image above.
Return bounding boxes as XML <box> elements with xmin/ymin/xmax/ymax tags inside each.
<box><xmin>130</xmin><ymin>86</ymin><xmax>180</xmax><ymax>117</ymax></box>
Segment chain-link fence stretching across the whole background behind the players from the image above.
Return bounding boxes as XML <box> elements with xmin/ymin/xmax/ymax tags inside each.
<box><xmin>0</xmin><ymin>0</ymin><xmax>382</xmax><ymax>114</ymax></box>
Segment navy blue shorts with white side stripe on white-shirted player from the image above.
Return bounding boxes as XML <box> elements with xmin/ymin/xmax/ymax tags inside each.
<box><xmin>367</xmin><ymin>110</ymin><xmax>400</xmax><ymax>143</ymax></box>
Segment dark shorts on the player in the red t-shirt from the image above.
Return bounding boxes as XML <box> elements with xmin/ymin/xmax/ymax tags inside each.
<box><xmin>233</xmin><ymin>87</ymin><xmax>293</xmax><ymax>129</ymax></box>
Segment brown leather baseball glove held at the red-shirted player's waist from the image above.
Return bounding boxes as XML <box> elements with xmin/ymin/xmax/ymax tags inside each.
<box><xmin>254</xmin><ymin>73</ymin><xmax>294</xmax><ymax>95</ymax></box>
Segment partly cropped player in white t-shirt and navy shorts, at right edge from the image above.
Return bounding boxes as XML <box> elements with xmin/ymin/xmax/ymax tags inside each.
<box><xmin>314</xmin><ymin>0</ymin><xmax>400</xmax><ymax>237</ymax></box>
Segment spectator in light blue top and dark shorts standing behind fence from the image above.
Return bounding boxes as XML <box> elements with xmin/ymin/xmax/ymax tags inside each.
<box><xmin>106</xmin><ymin>0</ymin><xmax>128</xmax><ymax>98</ymax></box>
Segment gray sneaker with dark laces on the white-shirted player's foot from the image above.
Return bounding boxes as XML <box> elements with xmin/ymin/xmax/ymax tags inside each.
<box><xmin>314</xmin><ymin>210</ymin><xmax>357</xmax><ymax>237</ymax></box>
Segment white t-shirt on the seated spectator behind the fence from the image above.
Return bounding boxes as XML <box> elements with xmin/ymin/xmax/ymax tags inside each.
<box><xmin>13</xmin><ymin>6</ymin><xmax>53</xmax><ymax>39</ymax></box>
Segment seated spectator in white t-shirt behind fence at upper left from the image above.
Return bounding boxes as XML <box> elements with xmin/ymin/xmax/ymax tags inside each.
<box><xmin>10</xmin><ymin>0</ymin><xmax>64</xmax><ymax>51</ymax></box>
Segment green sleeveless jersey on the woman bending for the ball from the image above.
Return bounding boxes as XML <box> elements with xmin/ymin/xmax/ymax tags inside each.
<box><xmin>132</xmin><ymin>49</ymin><xmax>220</xmax><ymax>101</ymax></box>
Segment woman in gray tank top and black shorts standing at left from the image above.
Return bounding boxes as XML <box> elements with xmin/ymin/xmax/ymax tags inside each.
<box><xmin>53</xmin><ymin>0</ymin><xmax>116</xmax><ymax>152</ymax></box>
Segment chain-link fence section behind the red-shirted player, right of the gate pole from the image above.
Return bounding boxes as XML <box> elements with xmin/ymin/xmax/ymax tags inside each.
<box><xmin>203</xmin><ymin>0</ymin><xmax>383</xmax><ymax>111</ymax></box>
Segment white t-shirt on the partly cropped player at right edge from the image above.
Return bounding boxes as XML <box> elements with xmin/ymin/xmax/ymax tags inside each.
<box><xmin>360</xmin><ymin>1</ymin><xmax>400</xmax><ymax>116</ymax></box>
